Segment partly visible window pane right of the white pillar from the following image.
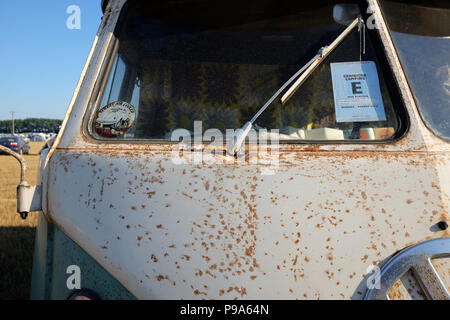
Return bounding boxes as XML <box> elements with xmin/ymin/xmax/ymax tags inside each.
<box><xmin>382</xmin><ymin>0</ymin><xmax>450</xmax><ymax>139</ymax></box>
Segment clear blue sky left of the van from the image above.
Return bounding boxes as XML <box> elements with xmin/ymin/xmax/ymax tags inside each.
<box><xmin>0</xmin><ymin>0</ymin><xmax>102</xmax><ymax>120</ymax></box>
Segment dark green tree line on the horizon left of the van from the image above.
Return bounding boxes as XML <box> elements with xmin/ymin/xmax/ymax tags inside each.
<box><xmin>0</xmin><ymin>118</ymin><xmax>62</xmax><ymax>133</ymax></box>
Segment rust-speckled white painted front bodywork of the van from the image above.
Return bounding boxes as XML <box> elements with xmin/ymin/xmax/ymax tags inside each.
<box><xmin>42</xmin><ymin>0</ymin><xmax>450</xmax><ymax>299</ymax></box>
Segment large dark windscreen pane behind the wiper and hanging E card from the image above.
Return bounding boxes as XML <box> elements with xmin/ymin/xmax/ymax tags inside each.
<box><xmin>92</xmin><ymin>0</ymin><xmax>399</xmax><ymax>141</ymax></box>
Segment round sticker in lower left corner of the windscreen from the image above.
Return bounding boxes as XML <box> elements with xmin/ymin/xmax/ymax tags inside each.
<box><xmin>94</xmin><ymin>101</ymin><xmax>136</xmax><ymax>138</ymax></box>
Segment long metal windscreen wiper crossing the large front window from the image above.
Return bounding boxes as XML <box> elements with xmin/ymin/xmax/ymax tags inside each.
<box><xmin>227</xmin><ymin>16</ymin><xmax>363</xmax><ymax>156</ymax></box>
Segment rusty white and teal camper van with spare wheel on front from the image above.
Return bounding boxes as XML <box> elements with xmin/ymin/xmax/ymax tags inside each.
<box><xmin>1</xmin><ymin>0</ymin><xmax>450</xmax><ymax>299</ymax></box>
